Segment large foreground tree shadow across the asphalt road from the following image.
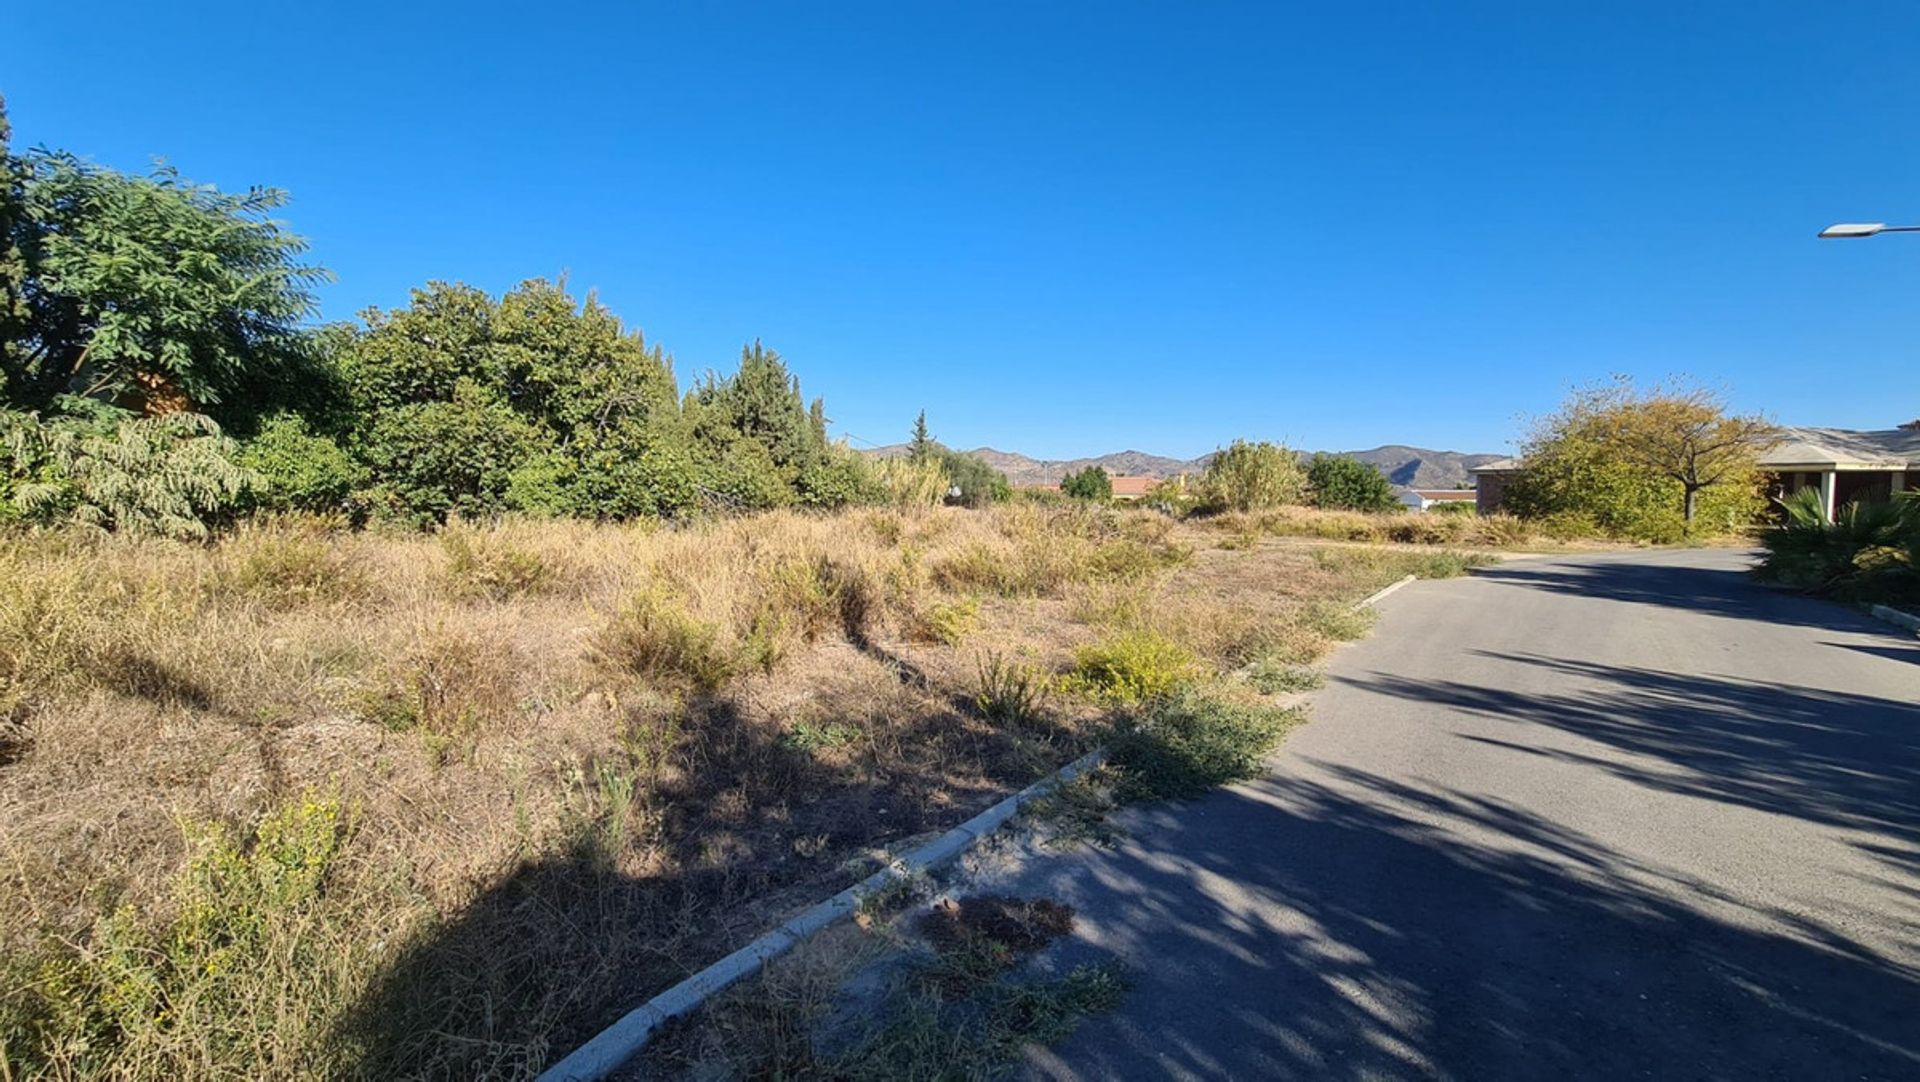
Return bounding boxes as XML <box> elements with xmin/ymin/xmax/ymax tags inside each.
<box><xmin>1021</xmin><ymin>767</ymin><xmax>1920</xmax><ymax>1080</ymax></box>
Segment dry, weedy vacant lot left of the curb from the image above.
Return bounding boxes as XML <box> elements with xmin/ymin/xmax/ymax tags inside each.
<box><xmin>0</xmin><ymin>506</ymin><xmax>1463</xmax><ymax>1078</ymax></box>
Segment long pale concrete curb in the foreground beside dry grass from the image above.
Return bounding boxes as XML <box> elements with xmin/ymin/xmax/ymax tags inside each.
<box><xmin>540</xmin><ymin>748</ymin><xmax>1113</xmax><ymax>1082</ymax></box>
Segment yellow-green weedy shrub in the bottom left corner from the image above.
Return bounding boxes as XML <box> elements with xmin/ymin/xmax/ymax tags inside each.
<box><xmin>0</xmin><ymin>794</ymin><xmax>359</xmax><ymax>1078</ymax></box>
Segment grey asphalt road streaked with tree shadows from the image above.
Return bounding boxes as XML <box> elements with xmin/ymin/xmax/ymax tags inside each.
<box><xmin>1000</xmin><ymin>551</ymin><xmax>1920</xmax><ymax>1080</ymax></box>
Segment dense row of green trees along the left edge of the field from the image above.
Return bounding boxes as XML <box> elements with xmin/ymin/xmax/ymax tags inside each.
<box><xmin>0</xmin><ymin>104</ymin><xmax>1006</xmax><ymax>535</ymax></box>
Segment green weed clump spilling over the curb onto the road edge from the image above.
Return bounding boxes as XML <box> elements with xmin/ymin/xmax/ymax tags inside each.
<box><xmin>1108</xmin><ymin>693</ymin><xmax>1304</xmax><ymax>800</ymax></box>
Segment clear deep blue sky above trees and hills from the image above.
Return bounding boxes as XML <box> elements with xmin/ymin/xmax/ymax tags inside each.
<box><xmin>0</xmin><ymin>0</ymin><xmax>1920</xmax><ymax>457</ymax></box>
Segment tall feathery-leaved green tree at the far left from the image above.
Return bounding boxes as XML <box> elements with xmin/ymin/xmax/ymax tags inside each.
<box><xmin>0</xmin><ymin>119</ymin><xmax>324</xmax><ymax>414</ymax></box>
